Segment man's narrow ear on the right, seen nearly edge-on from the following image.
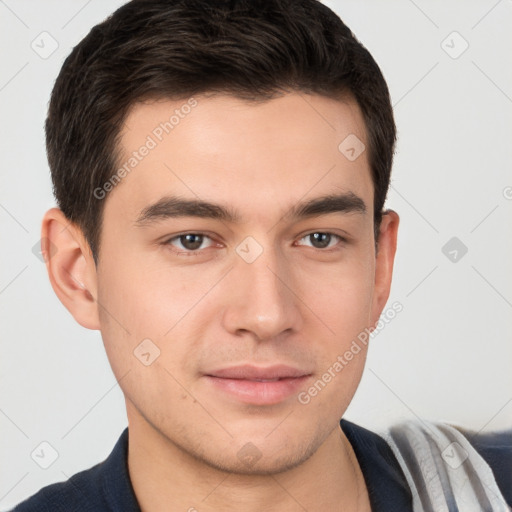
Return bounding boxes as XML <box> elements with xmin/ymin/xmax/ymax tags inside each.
<box><xmin>371</xmin><ymin>210</ymin><xmax>400</xmax><ymax>325</ymax></box>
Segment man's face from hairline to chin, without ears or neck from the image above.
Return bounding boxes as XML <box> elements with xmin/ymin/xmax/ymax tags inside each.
<box><xmin>92</xmin><ymin>93</ymin><xmax>396</xmax><ymax>473</ymax></box>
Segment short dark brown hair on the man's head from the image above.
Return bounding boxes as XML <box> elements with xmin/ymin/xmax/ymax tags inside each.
<box><xmin>46</xmin><ymin>0</ymin><xmax>396</xmax><ymax>262</ymax></box>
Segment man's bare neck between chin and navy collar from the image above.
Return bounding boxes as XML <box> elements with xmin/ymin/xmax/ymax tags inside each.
<box><xmin>128</xmin><ymin>412</ymin><xmax>370</xmax><ymax>512</ymax></box>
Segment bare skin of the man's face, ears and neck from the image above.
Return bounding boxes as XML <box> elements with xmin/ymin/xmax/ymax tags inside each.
<box><xmin>42</xmin><ymin>93</ymin><xmax>399</xmax><ymax>512</ymax></box>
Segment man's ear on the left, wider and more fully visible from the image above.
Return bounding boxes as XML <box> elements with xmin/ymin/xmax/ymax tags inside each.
<box><xmin>41</xmin><ymin>208</ymin><xmax>100</xmax><ymax>329</ymax></box>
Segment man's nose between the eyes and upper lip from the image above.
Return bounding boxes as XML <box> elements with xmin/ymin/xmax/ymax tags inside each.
<box><xmin>223</xmin><ymin>243</ymin><xmax>302</xmax><ymax>341</ymax></box>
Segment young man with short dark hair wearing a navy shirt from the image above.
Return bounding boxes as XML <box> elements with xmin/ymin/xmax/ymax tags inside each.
<box><xmin>11</xmin><ymin>0</ymin><xmax>512</xmax><ymax>512</ymax></box>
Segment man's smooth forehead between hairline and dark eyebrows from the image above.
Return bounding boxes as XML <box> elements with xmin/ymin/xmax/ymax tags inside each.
<box><xmin>106</xmin><ymin>93</ymin><xmax>373</xmax><ymax>222</ymax></box>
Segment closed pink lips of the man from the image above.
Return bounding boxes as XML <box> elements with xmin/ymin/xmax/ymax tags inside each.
<box><xmin>204</xmin><ymin>365</ymin><xmax>311</xmax><ymax>405</ymax></box>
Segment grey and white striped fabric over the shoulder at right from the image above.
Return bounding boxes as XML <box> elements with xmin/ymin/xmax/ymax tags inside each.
<box><xmin>379</xmin><ymin>419</ymin><xmax>511</xmax><ymax>512</ymax></box>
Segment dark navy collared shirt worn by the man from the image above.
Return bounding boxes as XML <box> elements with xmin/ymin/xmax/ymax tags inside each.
<box><xmin>14</xmin><ymin>419</ymin><xmax>512</xmax><ymax>512</ymax></box>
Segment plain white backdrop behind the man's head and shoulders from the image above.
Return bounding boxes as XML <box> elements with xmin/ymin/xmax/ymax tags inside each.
<box><xmin>0</xmin><ymin>0</ymin><xmax>512</xmax><ymax>510</ymax></box>
